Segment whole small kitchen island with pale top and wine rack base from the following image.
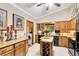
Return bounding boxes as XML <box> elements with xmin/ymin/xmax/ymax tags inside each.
<box><xmin>40</xmin><ymin>37</ymin><xmax>53</xmax><ymax>56</ymax></box>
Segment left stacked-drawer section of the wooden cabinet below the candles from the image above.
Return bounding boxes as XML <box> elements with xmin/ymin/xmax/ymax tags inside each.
<box><xmin>0</xmin><ymin>45</ymin><xmax>14</xmax><ymax>56</ymax></box>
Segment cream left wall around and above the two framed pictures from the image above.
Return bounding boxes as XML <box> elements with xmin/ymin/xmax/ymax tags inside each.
<box><xmin>0</xmin><ymin>3</ymin><xmax>35</xmax><ymax>42</ymax></box>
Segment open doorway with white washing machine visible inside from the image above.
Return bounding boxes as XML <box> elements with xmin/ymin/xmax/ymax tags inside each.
<box><xmin>26</xmin><ymin>20</ymin><xmax>34</xmax><ymax>45</ymax></box>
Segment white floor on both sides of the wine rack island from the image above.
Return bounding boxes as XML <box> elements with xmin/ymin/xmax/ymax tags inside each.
<box><xmin>26</xmin><ymin>43</ymin><xmax>78</xmax><ymax>56</ymax></box>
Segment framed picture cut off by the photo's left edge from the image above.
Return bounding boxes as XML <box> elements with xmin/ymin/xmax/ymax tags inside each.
<box><xmin>0</xmin><ymin>9</ymin><xmax>7</xmax><ymax>30</ymax></box>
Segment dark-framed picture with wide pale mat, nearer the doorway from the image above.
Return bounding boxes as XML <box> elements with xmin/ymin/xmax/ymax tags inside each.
<box><xmin>13</xmin><ymin>14</ymin><xmax>24</xmax><ymax>30</ymax></box>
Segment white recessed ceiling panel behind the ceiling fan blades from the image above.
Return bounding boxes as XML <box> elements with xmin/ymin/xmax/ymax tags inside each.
<box><xmin>10</xmin><ymin>3</ymin><xmax>71</xmax><ymax>19</ymax></box>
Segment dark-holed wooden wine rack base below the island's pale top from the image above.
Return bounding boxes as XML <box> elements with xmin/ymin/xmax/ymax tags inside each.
<box><xmin>40</xmin><ymin>41</ymin><xmax>53</xmax><ymax>56</ymax></box>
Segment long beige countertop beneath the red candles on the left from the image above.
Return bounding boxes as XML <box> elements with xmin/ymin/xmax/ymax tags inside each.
<box><xmin>0</xmin><ymin>36</ymin><xmax>28</xmax><ymax>48</ymax></box>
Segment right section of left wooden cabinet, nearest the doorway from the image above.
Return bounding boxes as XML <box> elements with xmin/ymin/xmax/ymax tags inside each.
<box><xmin>15</xmin><ymin>41</ymin><xmax>26</xmax><ymax>56</ymax></box>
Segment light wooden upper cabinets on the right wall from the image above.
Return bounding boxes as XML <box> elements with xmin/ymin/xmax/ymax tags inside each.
<box><xmin>54</xmin><ymin>18</ymin><xmax>76</xmax><ymax>32</ymax></box>
